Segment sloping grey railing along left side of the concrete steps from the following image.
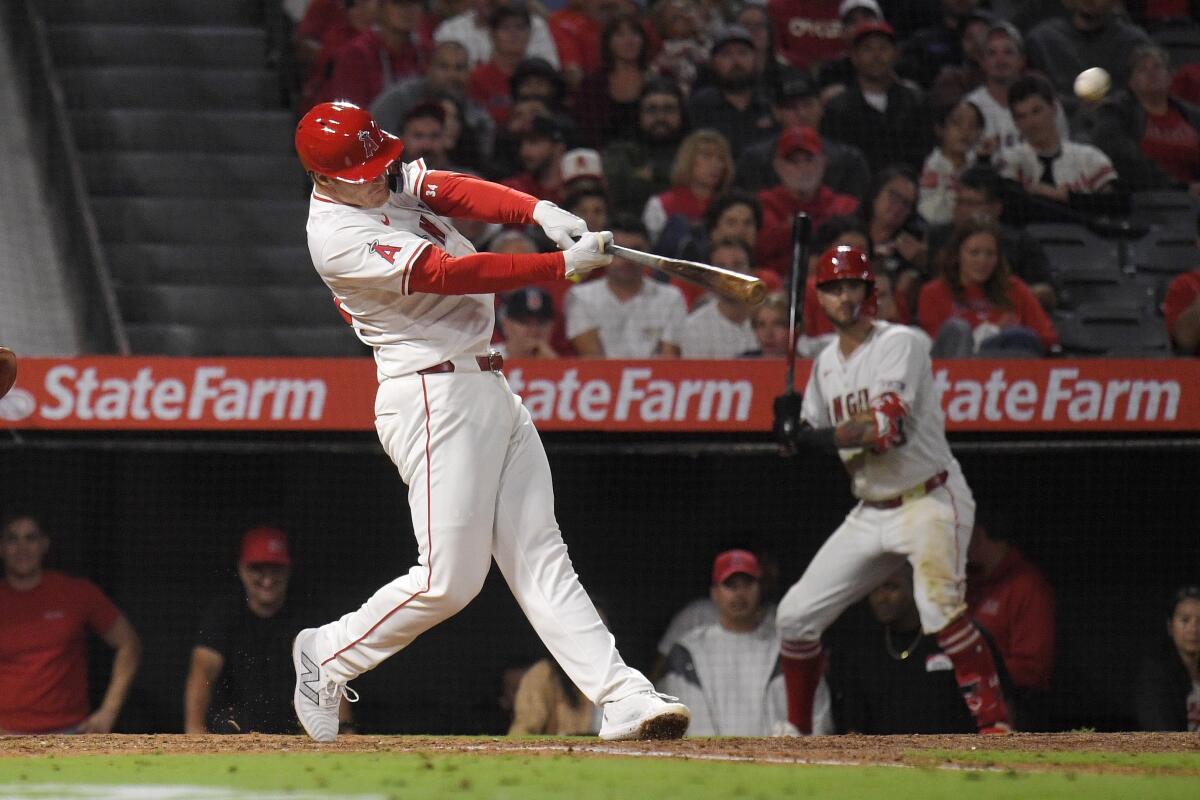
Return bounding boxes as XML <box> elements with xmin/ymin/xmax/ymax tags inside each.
<box><xmin>0</xmin><ymin>0</ymin><xmax>130</xmax><ymax>355</ymax></box>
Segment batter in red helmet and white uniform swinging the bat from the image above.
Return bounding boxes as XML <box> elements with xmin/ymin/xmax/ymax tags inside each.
<box><xmin>284</xmin><ymin>103</ymin><xmax>689</xmax><ymax>741</ymax></box>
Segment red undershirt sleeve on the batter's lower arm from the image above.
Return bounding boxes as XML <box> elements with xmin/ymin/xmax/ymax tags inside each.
<box><xmin>406</xmin><ymin>246</ymin><xmax>565</xmax><ymax>295</ymax></box>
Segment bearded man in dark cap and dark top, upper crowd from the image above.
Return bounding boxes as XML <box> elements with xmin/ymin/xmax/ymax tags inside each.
<box><xmin>689</xmin><ymin>25</ymin><xmax>774</xmax><ymax>157</ymax></box>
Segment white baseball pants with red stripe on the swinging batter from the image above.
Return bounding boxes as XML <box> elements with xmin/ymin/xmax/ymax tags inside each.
<box><xmin>304</xmin><ymin>356</ymin><xmax>653</xmax><ymax>704</ymax></box>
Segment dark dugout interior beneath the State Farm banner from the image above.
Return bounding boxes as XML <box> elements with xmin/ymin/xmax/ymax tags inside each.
<box><xmin>0</xmin><ymin>439</ymin><xmax>1200</xmax><ymax>733</ymax></box>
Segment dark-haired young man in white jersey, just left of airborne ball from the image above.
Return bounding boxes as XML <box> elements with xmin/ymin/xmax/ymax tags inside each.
<box><xmin>994</xmin><ymin>76</ymin><xmax>1117</xmax><ymax>203</ymax></box>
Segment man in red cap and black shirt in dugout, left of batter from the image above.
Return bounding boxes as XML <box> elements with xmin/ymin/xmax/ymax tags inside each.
<box><xmin>184</xmin><ymin>527</ymin><xmax>349</xmax><ymax>734</ymax></box>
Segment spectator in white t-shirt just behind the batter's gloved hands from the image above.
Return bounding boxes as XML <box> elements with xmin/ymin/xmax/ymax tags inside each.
<box><xmin>565</xmin><ymin>218</ymin><xmax>688</xmax><ymax>359</ymax></box>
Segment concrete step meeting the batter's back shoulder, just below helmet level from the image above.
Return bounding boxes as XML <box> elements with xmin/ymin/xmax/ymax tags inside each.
<box><xmin>92</xmin><ymin>197</ymin><xmax>308</xmax><ymax>246</ymax></box>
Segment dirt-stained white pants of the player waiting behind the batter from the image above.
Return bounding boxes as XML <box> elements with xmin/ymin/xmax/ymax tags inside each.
<box><xmin>776</xmin><ymin>462</ymin><xmax>974</xmax><ymax>642</ymax></box>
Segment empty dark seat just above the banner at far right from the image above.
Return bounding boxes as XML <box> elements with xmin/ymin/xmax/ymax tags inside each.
<box><xmin>1054</xmin><ymin>305</ymin><xmax>1171</xmax><ymax>359</ymax></box>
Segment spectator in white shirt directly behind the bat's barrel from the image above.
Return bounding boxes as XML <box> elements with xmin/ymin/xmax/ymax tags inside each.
<box><xmin>679</xmin><ymin>239</ymin><xmax>758</xmax><ymax>359</ymax></box>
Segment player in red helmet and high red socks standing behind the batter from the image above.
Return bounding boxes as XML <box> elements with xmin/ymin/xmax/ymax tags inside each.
<box><xmin>775</xmin><ymin>246</ymin><xmax>1012</xmax><ymax>733</ymax></box>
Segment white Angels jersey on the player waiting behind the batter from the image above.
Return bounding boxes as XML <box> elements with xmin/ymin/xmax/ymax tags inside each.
<box><xmin>802</xmin><ymin>321</ymin><xmax>954</xmax><ymax>500</ymax></box>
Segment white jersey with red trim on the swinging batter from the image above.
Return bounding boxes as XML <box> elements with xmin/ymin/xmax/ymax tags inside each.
<box><xmin>308</xmin><ymin>161</ymin><xmax>496</xmax><ymax>380</ymax></box>
